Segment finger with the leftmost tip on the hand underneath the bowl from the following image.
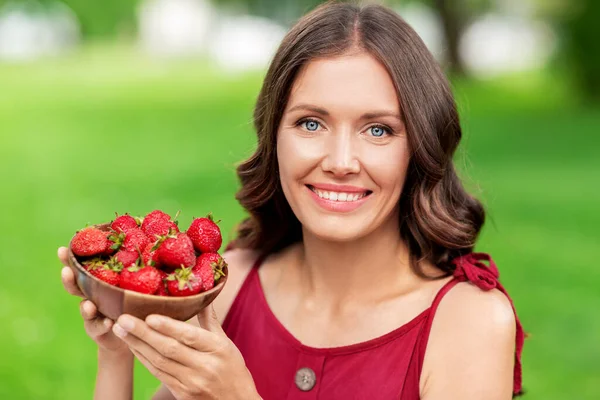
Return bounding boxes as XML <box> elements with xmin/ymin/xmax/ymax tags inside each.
<box><xmin>113</xmin><ymin>315</ymin><xmax>198</xmax><ymax>367</ymax></box>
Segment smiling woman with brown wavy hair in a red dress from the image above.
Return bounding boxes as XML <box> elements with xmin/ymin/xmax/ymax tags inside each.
<box><xmin>59</xmin><ymin>3</ymin><xmax>523</xmax><ymax>400</ymax></box>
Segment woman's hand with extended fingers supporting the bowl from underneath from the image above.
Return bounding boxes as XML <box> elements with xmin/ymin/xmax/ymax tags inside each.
<box><xmin>113</xmin><ymin>305</ymin><xmax>260</xmax><ymax>400</ymax></box>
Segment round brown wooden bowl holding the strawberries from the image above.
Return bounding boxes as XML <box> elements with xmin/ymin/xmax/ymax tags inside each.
<box><xmin>69</xmin><ymin>224</ymin><xmax>228</xmax><ymax>321</ymax></box>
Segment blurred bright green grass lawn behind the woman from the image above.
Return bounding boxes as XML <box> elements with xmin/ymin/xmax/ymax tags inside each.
<box><xmin>0</xmin><ymin>43</ymin><xmax>600</xmax><ymax>400</ymax></box>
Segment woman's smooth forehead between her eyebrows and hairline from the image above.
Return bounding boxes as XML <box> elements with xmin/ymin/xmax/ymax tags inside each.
<box><xmin>288</xmin><ymin>52</ymin><xmax>400</xmax><ymax>113</ymax></box>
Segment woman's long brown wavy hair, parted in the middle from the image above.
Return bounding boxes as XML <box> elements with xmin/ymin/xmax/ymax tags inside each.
<box><xmin>232</xmin><ymin>2</ymin><xmax>485</xmax><ymax>276</ymax></box>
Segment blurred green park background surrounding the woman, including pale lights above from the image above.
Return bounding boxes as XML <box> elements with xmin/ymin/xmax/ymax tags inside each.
<box><xmin>0</xmin><ymin>0</ymin><xmax>600</xmax><ymax>400</ymax></box>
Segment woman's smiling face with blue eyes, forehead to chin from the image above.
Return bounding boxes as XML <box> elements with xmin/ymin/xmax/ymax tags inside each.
<box><xmin>277</xmin><ymin>52</ymin><xmax>409</xmax><ymax>241</ymax></box>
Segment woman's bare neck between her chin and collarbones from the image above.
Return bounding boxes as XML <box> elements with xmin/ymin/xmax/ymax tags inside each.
<box><xmin>299</xmin><ymin>216</ymin><xmax>416</xmax><ymax>302</ymax></box>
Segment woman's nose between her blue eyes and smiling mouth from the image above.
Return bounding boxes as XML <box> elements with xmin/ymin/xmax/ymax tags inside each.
<box><xmin>321</xmin><ymin>132</ymin><xmax>360</xmax><ymax>177</ymax></box>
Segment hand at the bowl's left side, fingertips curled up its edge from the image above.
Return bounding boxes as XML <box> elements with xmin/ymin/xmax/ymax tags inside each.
<box><xmin>58</xmin><ymin>247</ymin><xmax>129</xmax><ymax>355</ymax></box>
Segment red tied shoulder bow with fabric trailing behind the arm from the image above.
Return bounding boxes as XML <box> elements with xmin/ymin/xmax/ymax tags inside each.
<box><xmin>452</xmin><ymin>253</ymin><xmax>525</xmax><ymax>396</ymax></box>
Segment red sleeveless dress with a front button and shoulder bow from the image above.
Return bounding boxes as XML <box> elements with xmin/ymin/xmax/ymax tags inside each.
<box><xmin>223</xmin><ymin>253</ymin><xmax>523</xmax><ymax>400</ymax></box>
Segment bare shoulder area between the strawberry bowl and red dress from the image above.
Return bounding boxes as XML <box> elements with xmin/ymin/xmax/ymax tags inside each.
<box><xmin>213</xmin><ymin>248</ymin><xmax>259</xmax><ymax>323</ymax></box>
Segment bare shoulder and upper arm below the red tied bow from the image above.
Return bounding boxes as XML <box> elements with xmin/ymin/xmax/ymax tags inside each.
<box><xmin>421</xmin><ymin>282</ymin><xmax>516</xmax><ymax>399</ymax></box>
